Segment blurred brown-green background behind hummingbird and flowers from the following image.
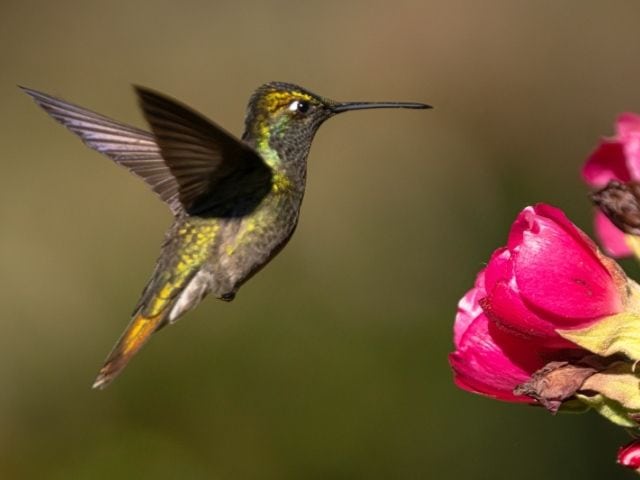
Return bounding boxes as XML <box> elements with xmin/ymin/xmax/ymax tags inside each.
<box><xmin>0</xmin><ymin>0</ymin><xmax>640</xmax><ymax>480</ymax></box>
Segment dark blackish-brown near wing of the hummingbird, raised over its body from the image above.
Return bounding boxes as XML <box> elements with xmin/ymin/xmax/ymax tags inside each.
<box><xmin>136</xmin><ymin>87</ymin><xmax>271</xmax><ymax>214</ymax></box>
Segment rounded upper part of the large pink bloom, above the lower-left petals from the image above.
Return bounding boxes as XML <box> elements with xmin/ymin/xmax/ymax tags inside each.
<box><xmin>480</xmin><ymin>204</ymin><xmax>626</xmax><ymax>348</ymax></box>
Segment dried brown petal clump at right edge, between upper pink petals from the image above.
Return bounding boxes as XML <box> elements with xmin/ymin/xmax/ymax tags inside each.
<box><xmin>591</xmin><ymin>180</ymin><xmax>640</xmax><ymax>235</ymax></box>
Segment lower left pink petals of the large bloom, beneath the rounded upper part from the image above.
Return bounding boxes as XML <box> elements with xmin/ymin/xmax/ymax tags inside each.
<box><xmin>449</xmin><ymin>271</ymin><xmax>545</xmax><ymax>403</ymax></box>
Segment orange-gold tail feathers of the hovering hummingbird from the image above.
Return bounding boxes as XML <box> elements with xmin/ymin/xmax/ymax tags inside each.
<box><xmin>92</xmin><ymin>310</ymin><xmax>166</xmax><ymax>389</ymax></box>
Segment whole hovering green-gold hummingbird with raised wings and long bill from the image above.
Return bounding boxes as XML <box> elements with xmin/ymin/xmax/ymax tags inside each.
<box><xmin>21</xmin><ymin>82</ymin><xmax>431</xmax><ymax>389</ymax></box>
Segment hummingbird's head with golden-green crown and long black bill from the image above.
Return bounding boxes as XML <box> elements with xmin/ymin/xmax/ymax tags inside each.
<box><xmin>243</xmin><ymin>82</ymin><xmax>430</xmax><ymax>164</ymax></box>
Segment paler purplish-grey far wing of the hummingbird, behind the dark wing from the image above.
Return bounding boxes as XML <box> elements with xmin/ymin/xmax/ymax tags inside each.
<box><xmin>21</xmin><ymin>87</ymin><xmax>183</xmax><ymax>215</ymax></box>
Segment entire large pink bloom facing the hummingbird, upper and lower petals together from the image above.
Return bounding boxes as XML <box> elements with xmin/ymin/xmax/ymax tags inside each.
<box><xmin>449</xmin><ymin>204</ymin><xmax>627</xmax><ymax>403</ymax></box>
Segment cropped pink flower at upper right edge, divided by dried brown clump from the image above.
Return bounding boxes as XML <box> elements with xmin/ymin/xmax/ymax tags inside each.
<box><xmin>582</xmin><ymin>113</ymin><xmax>640</xmax><ymax>257</ymax></box>
